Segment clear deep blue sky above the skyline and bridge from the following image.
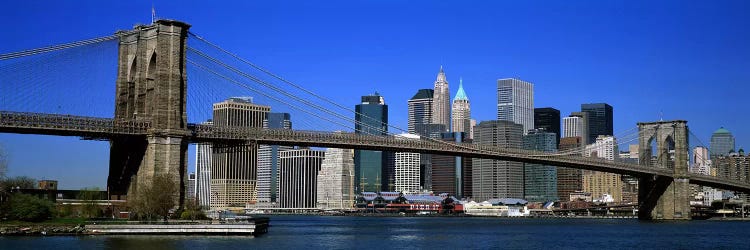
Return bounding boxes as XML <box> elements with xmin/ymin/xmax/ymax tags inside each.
<box><xmin>0</xmin><ymin>1</ymin><xmax>750</xmax><ymax>188</ymax></box>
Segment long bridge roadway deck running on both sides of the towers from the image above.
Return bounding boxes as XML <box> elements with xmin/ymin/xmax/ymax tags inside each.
<box><xmin>0</xmin><ymin>111</ymin><xmax>750</xmax><ymax>192</ymax></box>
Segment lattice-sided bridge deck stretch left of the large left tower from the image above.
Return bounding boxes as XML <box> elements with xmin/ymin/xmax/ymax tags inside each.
<box><xmin>0</xmin><ymin>111</ymin><xmax>150</xmax><ymax>134</ymax></box>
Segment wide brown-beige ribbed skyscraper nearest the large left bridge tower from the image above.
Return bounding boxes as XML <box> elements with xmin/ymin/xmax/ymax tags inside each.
<box><xmin>210</xmin><ymin>97</ymin><xmax>271</xmax><ymax>209</ymax></box>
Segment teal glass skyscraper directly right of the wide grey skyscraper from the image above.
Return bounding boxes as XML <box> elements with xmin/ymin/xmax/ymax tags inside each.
<box><xmin>523</xmin><ymin>129</ymin><xmax>558</xmax><ymax>202</ymax></box>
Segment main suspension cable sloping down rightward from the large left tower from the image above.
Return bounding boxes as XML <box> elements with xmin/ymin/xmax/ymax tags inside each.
<box><xmin>188</xmin><ymin>46</ymin><xmax>494</xmax><ymax>154</ymax></box>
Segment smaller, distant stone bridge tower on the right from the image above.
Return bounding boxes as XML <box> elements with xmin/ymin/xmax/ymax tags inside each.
<box><xmin>638</xmin><ymin>120</ymin><xmax>690</xmax><ymax>220</ymax></box>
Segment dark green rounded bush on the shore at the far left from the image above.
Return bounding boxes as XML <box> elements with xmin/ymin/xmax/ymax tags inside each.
<box><xmin>8</xmin><ymin>194</ymin><xmax>55</xmax><ymax>222</ymax></box>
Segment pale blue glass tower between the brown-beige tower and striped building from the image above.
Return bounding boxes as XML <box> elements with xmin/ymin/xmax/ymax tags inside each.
<box><xmin>258</xmin><ymin>113</ymin><xmax>294</xmax><ymax>203</ymax></box>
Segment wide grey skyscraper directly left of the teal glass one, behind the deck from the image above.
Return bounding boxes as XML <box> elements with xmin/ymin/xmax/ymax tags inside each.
<box><xmin>472</xmin><ymin>120</ymin><xmax>523</xmax><ymax>201</ymax></box>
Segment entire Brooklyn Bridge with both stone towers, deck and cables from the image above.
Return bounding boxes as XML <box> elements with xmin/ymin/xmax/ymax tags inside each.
<box><xmin>0</xmin><ymin>20</ymin><xmax>750</xmax><ymax>220</ymax></box>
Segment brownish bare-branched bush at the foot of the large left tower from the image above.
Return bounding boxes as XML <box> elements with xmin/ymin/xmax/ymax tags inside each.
<box><xmin>128</xmin><ymin>174</ymin><xmax>179</xmax><ymax>220</ymax></box>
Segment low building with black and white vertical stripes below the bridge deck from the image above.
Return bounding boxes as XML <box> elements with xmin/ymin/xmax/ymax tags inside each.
<box><xmin>278</xmin><ymin>149</ymin><xmax>325</xmax><ymax>208</ymax></box>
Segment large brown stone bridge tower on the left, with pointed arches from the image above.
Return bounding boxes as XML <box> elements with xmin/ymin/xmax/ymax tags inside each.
<box><xmin>107</xmin><ymin>20</ymin><xmax>190</xmax><ymax>206</ymax></box>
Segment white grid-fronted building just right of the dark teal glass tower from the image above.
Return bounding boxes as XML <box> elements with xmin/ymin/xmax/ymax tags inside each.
<box><xmin>394</xmin><ymin>134</ymin><xmax>421</xmax><ymax>193</ymax></box>
